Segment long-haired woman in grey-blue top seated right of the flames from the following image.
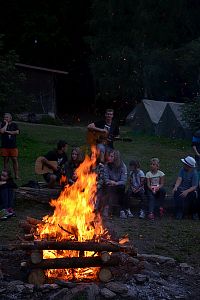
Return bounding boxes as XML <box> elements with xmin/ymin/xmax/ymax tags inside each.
<box><xmin>104</xmin><ymin>149</ymin><xmax>127</xmax><ymax>218</ymax></box>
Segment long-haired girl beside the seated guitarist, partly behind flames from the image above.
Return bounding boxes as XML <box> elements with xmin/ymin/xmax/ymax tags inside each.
<box><xmin>65</xmin><ymin>147</ymin><xmax>84</xmax><ymax>184</ymax></box>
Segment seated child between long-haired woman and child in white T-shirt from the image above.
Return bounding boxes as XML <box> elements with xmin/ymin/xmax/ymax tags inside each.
<box><xmin>127</xmin><ymin>160</ymin><xmax>145</xmax><ymax>219</ymax></box>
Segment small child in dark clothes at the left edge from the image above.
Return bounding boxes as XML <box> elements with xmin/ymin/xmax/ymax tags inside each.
<box><xmin>0</xmin><ymin>170</ymin><xmax>17</xmax><ymax>220</ymax></box>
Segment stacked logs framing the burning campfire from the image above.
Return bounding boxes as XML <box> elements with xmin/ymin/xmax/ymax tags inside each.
<box><xmin>14</xmin><ymin>217</ymin><xmax>137</xmax><ymax>285</ymax></box>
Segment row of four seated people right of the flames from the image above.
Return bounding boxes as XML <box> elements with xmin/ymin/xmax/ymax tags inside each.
<box><xmin>97</xmin><ymin>149</ymin><xmax>200</xmax><ymax>220</ymax></box>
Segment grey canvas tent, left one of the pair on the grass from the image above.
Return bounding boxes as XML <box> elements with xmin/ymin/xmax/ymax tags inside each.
<box><xmin>126</xmin><ymin>99</ymin><xmax>167</xmax><ymax>134</ymax></box>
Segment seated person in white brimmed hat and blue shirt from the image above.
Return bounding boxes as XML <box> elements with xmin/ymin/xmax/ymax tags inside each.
<box><xmin>173</xmin><ymin>156</ymin><xmax>198</xmax><ymax>220</ymax></box>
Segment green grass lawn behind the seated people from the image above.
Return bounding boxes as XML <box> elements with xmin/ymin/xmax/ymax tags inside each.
<box><xmin>0</xmin><ymin>123</ymin><xmax>193</xmax><ymax>190</ymax></box>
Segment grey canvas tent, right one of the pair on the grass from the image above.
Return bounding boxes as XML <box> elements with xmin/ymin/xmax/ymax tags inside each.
<box><xmin>156</xmin><ymin>102</ymin><xmax>192</xmax><ymax>139</ymax></box>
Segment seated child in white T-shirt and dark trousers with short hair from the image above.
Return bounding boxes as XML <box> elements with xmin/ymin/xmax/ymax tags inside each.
<box><xmin>146</xmin><ymin>158</ymin><xmax>166</xmax><ymax>220</ymax></box>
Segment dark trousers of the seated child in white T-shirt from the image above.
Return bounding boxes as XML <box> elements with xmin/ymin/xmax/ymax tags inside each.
<box><xmin>147</xmin><ymin>188</ymin><xmax>166</xmax><ymax>213</ymax></box>
